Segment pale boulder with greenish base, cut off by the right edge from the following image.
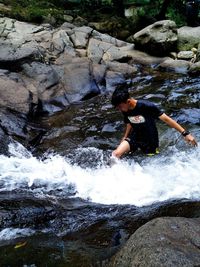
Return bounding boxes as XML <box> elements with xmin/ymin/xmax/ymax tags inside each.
<box><xmin>177</xmin><ymin>26</ymin><xmax>200</xmax><ymax>51</ymax></box>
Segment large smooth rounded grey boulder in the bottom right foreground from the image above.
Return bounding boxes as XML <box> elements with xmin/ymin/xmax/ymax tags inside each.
<box><xmin>109</xmin><ymin>217</ymin><xmax>200</xmax><ymax>267</ymax></box>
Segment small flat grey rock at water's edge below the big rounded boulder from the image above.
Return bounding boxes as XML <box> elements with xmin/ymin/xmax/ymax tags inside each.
<box><xmin>157</xmin><ymin>58</ymin><xmax>191</xmax><ymax>73</ymax></box>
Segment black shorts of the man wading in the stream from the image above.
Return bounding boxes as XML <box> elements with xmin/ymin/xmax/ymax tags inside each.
<box><xmin>125</xmin><ymin>138</ymin><xmax>159</xmax><ymax>156</ymax></box>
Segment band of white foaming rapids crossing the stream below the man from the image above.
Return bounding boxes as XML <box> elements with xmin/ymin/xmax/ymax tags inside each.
<box><xmin>0</xmin><ymin>143</ymin><xmax>200</xmax><ymax>206</ymax></box>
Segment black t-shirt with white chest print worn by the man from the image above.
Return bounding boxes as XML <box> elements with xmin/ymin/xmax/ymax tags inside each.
<box><xmin>123</xmin><ymin>100</ymin><xmax>163</xmax><ymax>147</ymax></box>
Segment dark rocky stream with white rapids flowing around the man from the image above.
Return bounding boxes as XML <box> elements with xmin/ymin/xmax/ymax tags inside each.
<box><xmin>0</xmin><ymin>68</ymin><xmax>200</xmax><ymax>266</ymax></box>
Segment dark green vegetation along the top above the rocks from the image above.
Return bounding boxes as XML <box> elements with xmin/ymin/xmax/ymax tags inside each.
<box><xmin>0</xmin><ymin>0</ymin><xmax>198</xmax><ymax>31</ymax></box>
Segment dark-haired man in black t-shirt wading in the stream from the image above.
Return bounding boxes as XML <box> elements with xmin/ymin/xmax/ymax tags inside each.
<box><xmin>111</xmin><ymin>87</ymin><xmax>197</xmax><ymax>158</ymax></box>
